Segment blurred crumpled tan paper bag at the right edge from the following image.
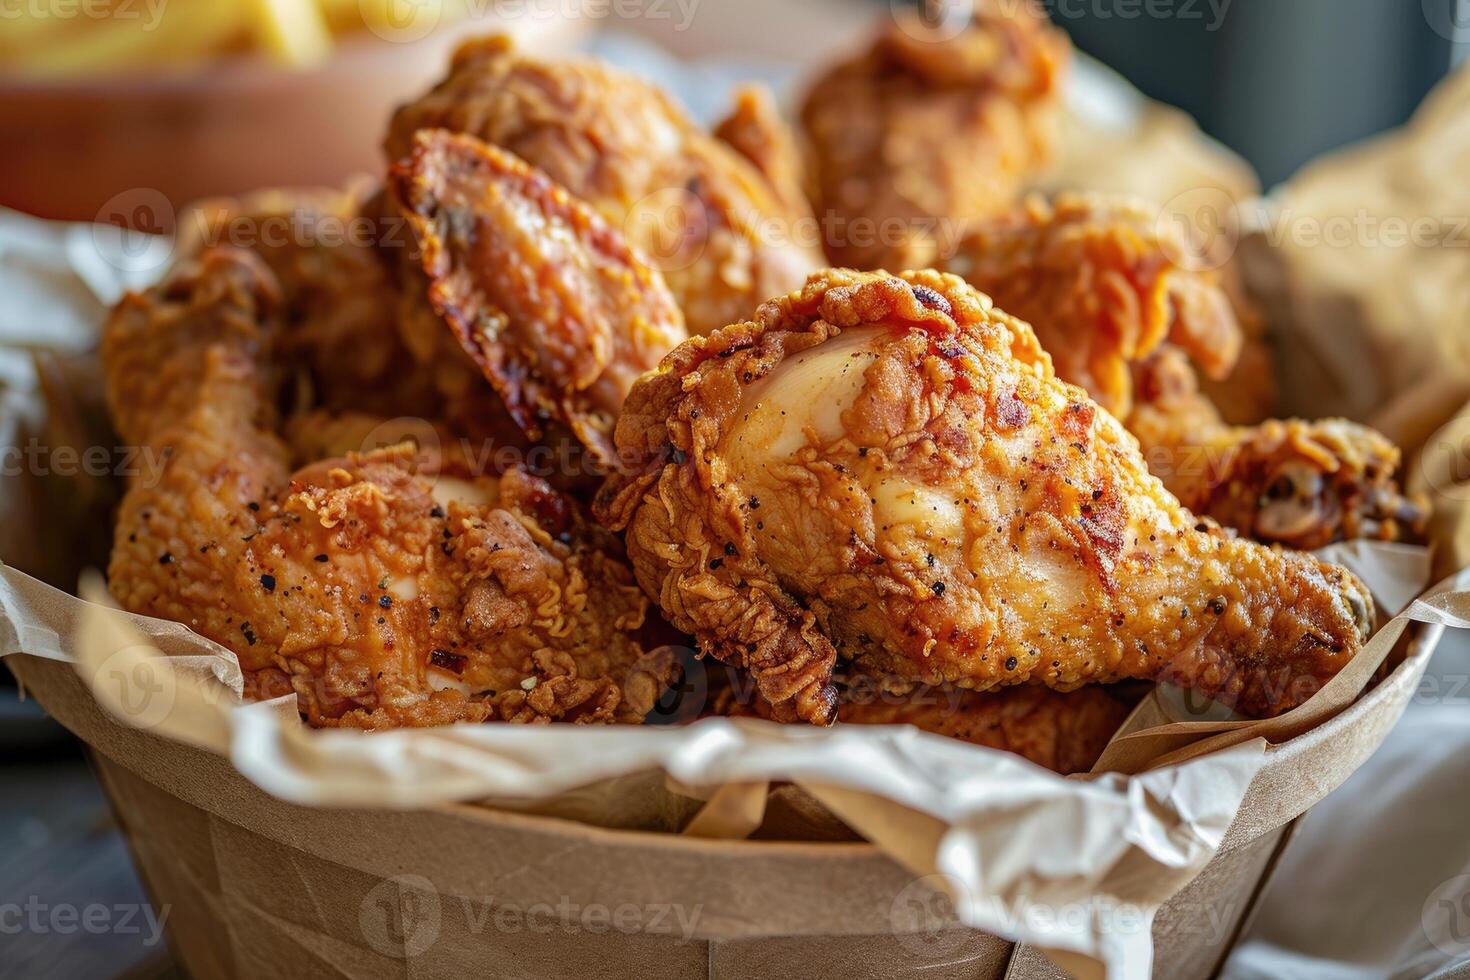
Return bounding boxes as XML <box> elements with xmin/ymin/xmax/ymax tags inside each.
<box><xmin>1241</xmin><ymin>59</ymin><xmax>1470</xmax><ymax>574</ymax></box>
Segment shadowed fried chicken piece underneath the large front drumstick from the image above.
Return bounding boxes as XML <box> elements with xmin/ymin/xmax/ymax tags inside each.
<box><xmin>710</xmin><ymin>679</ymin><xmax>1147</xmax><ymax>776</ymax></box>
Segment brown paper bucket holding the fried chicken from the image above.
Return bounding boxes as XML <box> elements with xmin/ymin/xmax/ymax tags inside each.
<box><xmin>7</xmin><ymin>587</ymin><xmax>1441</xmax><ymax>980</ymax></box>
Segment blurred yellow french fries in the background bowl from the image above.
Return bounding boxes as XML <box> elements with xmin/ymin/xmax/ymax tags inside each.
<box><xmin>0</xmin><ymin>0</ymin><xmax>467</xmax><ymax>78</ymax></box>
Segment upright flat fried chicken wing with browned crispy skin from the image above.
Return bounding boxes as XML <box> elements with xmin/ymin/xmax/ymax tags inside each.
<box><xmin>390</xmin><ymin>129</ymin><xmax>688</xmax><ymax>466</ymax></box>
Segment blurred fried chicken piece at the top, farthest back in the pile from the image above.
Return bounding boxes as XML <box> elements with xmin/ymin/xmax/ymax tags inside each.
<box><xmin>801</xmin><ymin>0</ymin><xmax>1070</xmax><ymax>269</ymax></box>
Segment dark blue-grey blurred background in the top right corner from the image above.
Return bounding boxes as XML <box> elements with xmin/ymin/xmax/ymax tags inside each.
<box><xmin>1044</xmin><ymin>0</ymin><xmax>1470</xmax><ymax>187</ymax></box>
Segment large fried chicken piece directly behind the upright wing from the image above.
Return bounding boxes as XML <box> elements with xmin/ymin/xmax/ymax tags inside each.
<box><xmin>387</xmin><ymin>37</ymin><xmax>822</xmax><ymax>334</ymax></box>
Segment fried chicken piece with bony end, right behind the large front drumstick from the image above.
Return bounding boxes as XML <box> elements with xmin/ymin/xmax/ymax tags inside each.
<box><xmin>941</xmin><ymin>194</ymin><xmax>1427</xmax><ymax>550</ymax></box>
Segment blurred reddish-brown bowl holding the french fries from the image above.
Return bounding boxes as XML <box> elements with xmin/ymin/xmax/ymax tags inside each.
<box><xmin>0</xmin><ymin>13</ymin><xmax>592</xmax><ymax>232</ymax></box>
